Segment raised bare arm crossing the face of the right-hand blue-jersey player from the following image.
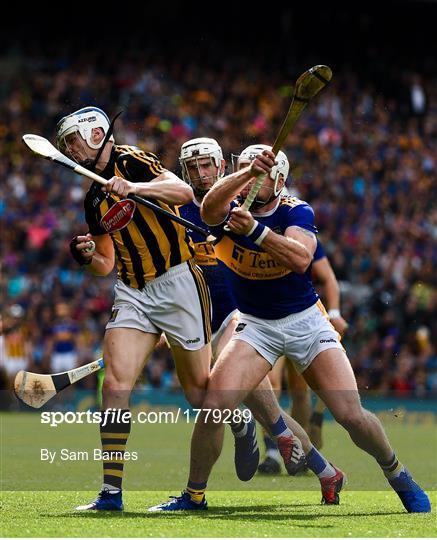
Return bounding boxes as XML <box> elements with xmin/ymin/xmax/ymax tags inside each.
<box><xmin>201</xmin><ymin>150</ymin><xmax>275</xmax><ymax>225</ymax></box>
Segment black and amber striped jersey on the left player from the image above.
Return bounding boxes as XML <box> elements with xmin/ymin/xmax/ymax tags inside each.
<box><xmin>84</xmin><ymin>145</ymin><xmax>194</xmax><ymax>289</ymax></box>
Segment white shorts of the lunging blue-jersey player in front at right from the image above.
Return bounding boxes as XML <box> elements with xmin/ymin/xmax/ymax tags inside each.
<box><xmin>232</xmin><ymin>300</ymin><xmax>344</xmax><ymax>373</ymax></box>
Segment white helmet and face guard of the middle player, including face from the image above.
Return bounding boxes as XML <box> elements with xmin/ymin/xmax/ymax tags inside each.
<box><xmin>179</xmin><ymin>137</ymin><xmax>225</xmax><ymax>197</ymax></box>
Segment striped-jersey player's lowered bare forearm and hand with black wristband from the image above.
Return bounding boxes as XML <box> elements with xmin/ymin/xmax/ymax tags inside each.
<box><xmin>75</xmin><ymin>233</ymin><xmax>115</xmax><ymax>276</ymax></box>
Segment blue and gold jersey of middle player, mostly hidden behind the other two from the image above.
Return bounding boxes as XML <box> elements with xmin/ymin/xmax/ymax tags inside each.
<box><xmin>179</xmin><ymin>200</ymin><xmax>237</xmax><ymax>333</ymax></box>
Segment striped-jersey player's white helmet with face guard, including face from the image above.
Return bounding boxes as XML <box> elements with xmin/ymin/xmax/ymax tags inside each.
<box><xmin>56</xmin><ymin>107</ymin><xmax>114</xmax><ymax>165</ymax></box>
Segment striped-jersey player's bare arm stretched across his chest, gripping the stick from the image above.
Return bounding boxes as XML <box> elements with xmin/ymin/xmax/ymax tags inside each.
<box><xmin>102</xmin><ymin>170</ymin><xmax>194</xmax><ymax>205</ymax></box>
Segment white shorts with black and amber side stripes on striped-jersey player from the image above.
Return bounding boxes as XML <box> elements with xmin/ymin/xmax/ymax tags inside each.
<box><xmin>106</xmin><ymin>261</ymin><xmax>211</xmax><ymax>351</ymax></box>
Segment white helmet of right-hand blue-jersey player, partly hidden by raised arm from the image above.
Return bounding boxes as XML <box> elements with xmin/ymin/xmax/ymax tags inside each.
<box><xmin>231</xmin><ymin>144</ymin><xmax>290</xmax><ymax>209</ymax></box>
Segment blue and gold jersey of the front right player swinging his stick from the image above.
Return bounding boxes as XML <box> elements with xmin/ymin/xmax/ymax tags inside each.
<box><xmin>211</xmin><ymin>197</ymin><xmax>319</xmax><ymax>319</ymax></box>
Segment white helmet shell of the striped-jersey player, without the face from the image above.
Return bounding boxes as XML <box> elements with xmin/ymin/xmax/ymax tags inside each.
<box><xmin>56</xmin><ymin>107</ymin><xmax>114</xmax><ymax>150</ymax></box>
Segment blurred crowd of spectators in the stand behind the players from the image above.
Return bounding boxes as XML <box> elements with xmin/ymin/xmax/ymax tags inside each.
<box><xmin>0</xmin><ymin>44</ymin><xmax>437</xmax><ymax>397</ymax></box>
